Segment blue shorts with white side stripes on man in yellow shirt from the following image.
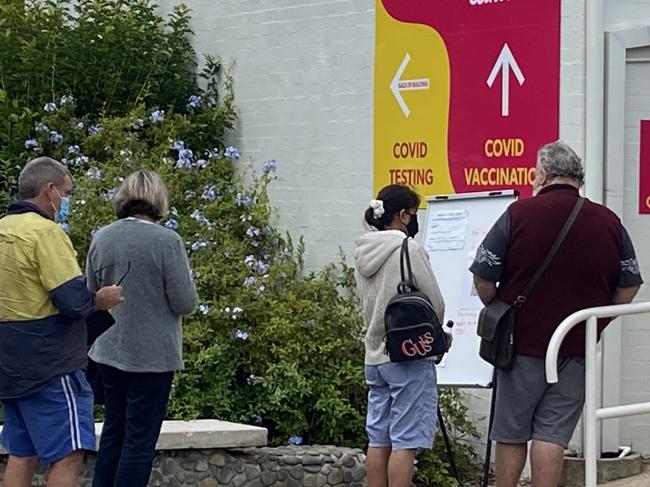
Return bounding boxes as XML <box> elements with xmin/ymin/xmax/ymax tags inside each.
<box><xmin>0</xmin><ymin>370</ymin><xmax>95</xmax><ymax>465</ymax></box>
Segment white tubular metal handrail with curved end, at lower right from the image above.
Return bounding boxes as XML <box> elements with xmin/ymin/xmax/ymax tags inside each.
<box><xmin>545</xmin><ymin>301</ymin><xmax>650</xmax><ymax>487</ymax></box>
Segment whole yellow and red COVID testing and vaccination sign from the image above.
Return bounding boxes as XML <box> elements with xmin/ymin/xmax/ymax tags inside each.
<box><xmin>374</xmin><ymin>0</ymin><xmax>560</xmax><ymax>204</ymax></box>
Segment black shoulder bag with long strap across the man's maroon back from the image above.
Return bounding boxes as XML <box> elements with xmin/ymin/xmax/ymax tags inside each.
<box><xmin>476</xmin><ymin>197</ymin><xmax>584</xmax><ymax>369</ymax></box>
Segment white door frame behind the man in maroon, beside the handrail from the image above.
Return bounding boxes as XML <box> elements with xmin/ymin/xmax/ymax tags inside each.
<box><xmin>601</xmin><ymin>26</ymin><xmax>650</xmax><ymax>451</ymax></box>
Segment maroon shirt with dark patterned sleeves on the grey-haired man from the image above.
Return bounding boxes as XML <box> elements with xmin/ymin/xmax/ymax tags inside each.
<box><xmin>470</xmin><ymin>184</ymin><xmax>643</xmax><ymax>357</ymax></box>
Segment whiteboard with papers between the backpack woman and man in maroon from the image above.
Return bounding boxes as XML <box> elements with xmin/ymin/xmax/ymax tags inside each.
<box><xmin>422</xmin><ymin>190</ymin><xmax>517</xmax><ymax>387</ymax></box>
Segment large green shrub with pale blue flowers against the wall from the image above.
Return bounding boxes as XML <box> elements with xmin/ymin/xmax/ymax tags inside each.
<box><xmin>0</xmin><ymin>0</ymin><xmax>472</xmax><ymax>485</ymax></box>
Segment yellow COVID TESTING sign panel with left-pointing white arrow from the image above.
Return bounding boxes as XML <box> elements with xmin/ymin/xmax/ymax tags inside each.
<box><xmin>374</xmin><ymin>0</ymin><xmax>453</xmax><ymax>207</ymax></box>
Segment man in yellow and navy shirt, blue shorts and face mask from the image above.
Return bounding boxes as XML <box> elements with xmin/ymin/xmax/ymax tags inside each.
<box><xmin>0</xmin><ymin>157</ymin><xmax>123</xmax><ymax>487</ymax></box>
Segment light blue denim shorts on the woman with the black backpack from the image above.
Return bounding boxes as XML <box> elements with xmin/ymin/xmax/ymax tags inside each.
<box><xmin>366</xmin><ymin>360</ymin><xmax>438</xmax><ymax>450</ymax></box>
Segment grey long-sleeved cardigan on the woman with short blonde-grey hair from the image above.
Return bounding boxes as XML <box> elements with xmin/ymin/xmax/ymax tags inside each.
<box><xmin>86</xmin><ymin>218</ymin><xmax>198</xmax><ymax>372</ymax></box>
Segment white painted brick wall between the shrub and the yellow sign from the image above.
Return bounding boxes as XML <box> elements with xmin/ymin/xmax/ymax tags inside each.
<box><xmin>156</xmin><ymin>0</ymin><xmax>374</xmax><ymax>268</ymax></box>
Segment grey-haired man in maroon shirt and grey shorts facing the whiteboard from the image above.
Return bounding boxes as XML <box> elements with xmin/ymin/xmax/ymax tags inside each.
<box><xmin>470</xmin><ymin>141</ymin><xmax>643</xmax><ymax>487</ymax></box>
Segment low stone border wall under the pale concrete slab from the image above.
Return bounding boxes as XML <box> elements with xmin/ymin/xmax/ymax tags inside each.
<box><xmin>0</xmin><ymin>446</ymin><xmax>366</xmax><ymax>487</ymax></box>
